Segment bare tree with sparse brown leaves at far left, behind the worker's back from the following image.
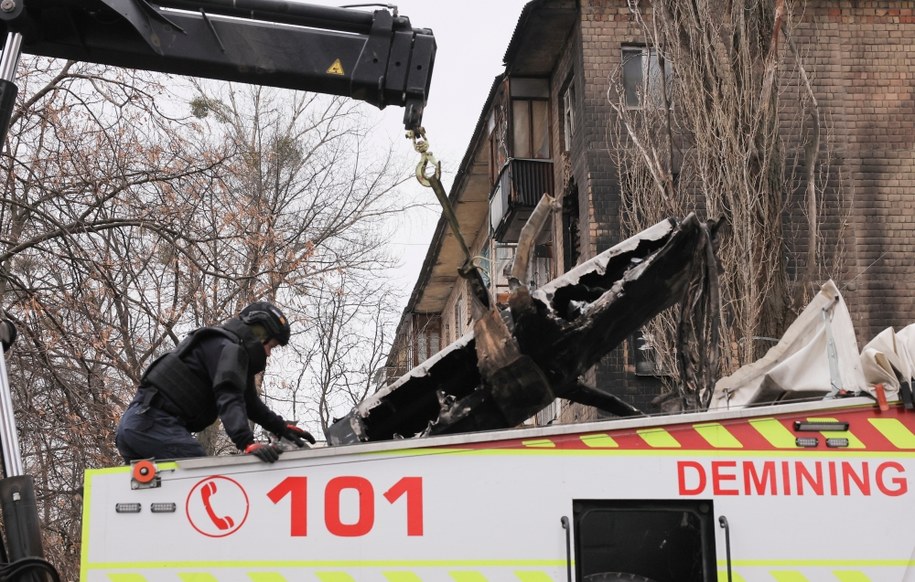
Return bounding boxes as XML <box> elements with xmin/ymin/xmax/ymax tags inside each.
<box><xmin>0</xmin><ymin>59</ymin><xmax>233</xmax><ymax>579</ymax></box>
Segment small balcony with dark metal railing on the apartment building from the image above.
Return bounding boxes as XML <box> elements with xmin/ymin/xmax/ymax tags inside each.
<box><xmin>489</xmin><ymin>158</ymin><xmax>553</xmax><ymax>243</ymax></box>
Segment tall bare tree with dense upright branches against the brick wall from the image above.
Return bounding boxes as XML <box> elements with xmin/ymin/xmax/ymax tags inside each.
<box><xmin>608</xmin><ymin>0</ymin><xmax>844</xmax><ymax>408</ymax></box>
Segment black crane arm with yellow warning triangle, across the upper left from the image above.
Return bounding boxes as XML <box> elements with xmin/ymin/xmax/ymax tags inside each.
<box><xmin>0</xmin><ymin>0</ymin><xmax>436</xmax><ymax>129</ymax></box>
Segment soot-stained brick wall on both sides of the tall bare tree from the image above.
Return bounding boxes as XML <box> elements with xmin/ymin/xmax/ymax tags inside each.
<box><xmin>554</xmin><ymin>0</ymin><xmax>915</xmax><ymax>421</ymax></box>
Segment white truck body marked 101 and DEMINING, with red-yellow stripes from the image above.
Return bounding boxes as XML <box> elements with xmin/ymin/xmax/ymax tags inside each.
<box><xmin>81</xmin><ymin>397</ymin><xmax>915</xmax><ymax>582</ymax></box>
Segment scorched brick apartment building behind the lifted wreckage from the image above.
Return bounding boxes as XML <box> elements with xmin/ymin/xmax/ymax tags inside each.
<box><xmin>386</xmin><ymin>0</ymin><xmax>915</xmax><ymax>424</ymax></box>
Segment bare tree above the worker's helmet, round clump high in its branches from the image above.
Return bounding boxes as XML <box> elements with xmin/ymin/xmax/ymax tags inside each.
<box><xmin>182</xmin><ymin>85</ymin><xmax>410</xmax><ymax>448</ymax></box>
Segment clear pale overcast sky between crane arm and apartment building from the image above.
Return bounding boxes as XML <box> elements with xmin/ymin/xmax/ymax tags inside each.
<box><xmin>307</xmin><ymin>0</ymin><xmax>528</xmax><ymax>308</ymax></box>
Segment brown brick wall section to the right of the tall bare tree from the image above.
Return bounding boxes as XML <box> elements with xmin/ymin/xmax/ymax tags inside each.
<box><xmin>786</xmin><ymin>0</ymin><xmax>915</xmax><ymax>344</ymax></box>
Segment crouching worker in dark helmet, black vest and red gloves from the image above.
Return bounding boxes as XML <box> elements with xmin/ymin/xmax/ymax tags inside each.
<box><xmin>115</xmin><ymin>301</ymin><xmax>315</xmax><ymax>463</ymax></box>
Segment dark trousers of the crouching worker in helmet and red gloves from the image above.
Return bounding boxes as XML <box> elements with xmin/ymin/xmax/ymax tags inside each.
<box><xmin>115</xmin><ymin>397</ymin><xmax>206</xmax><ymax>463</ymax></box>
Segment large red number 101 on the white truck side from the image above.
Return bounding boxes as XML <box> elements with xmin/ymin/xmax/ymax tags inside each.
<box><xmin>267</xmin><ymin>476</ymin><xmax>423</xmax><ymax>537</ymax></box>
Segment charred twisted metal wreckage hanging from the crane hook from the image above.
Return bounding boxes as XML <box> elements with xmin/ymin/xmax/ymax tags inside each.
<box><xmin>327</xmin><ymin>214</ymin><xmax>720</xmax><ymax>445</ymax></box>
